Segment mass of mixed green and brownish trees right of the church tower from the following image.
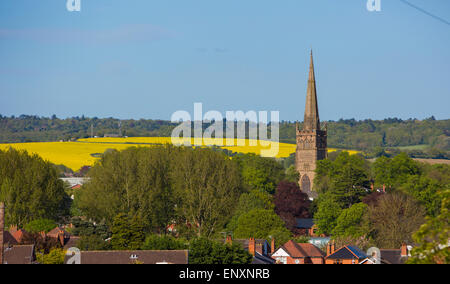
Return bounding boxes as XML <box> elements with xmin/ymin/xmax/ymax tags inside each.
<box><xmin>311</xmin><ymin>152</ymin><xmax>450</xmax><ymax>262</ymax></box>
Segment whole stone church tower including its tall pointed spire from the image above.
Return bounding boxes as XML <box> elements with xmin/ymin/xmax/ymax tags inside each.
<box><xmin>295</xmin><ymin>51</ymin><xmax>327</xmax><ymax>198</ymax></box>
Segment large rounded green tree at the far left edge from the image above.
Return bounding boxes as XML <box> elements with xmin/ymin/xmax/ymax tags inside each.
<box><xmin>0</xmin><ymin>148</ymin><xmax>70</xmax><ymax>227</ymax></box>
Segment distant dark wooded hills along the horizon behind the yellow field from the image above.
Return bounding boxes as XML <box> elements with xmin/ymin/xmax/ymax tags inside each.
<box><xmin>0</xmin><ymin>115</ymin><xmax>450</xmax><ymax>159</ymax></box>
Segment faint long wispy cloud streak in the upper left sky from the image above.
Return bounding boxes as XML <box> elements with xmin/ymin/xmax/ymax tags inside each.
<box><xmin>0</xmin><ymin>25</ymin><xmax>175</xmax><ymax>43</ymax></box>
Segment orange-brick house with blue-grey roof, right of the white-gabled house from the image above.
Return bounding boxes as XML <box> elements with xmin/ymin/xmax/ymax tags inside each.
<box><xmin>325</xmin><ymin>242</ymin><xmax>368</xmax><ymax>264</ymax></box>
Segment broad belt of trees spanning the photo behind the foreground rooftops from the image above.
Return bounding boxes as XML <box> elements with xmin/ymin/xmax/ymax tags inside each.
<box><xmin>0</xmin><ymin>145</ymin><xmax>450</xmax><ymax>263</ymax></box>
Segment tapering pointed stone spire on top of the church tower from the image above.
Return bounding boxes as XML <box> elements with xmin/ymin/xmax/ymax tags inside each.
<box><xmin>303</xmin><ymin>50</ymin><xmax>320</xmax><ymax>131</ymax></box>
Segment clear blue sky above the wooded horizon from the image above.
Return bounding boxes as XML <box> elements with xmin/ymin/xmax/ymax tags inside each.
<box><xmin>0</xmin><ymin>0</ymin><xmax>450</xmax><ymax>120</ymax></box>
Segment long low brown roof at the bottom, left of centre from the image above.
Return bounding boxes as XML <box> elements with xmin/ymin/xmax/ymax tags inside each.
<box><xmin>64</xmin><ymin>250</ymin><xmax>189</xmax><ymax>264</ymax></box>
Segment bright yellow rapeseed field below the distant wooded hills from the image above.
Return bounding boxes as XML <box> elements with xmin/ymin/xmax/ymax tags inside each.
<box><xmin>0</xmin><ymin>137</ymin><xmax>357</xmax><ymax>170</ymax></box>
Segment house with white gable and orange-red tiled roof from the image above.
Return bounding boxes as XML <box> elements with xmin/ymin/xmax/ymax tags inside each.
<box><xmin>272</xmin><ymin>240</ymin><xmax>325</xmax><ymax>264</ymax></box>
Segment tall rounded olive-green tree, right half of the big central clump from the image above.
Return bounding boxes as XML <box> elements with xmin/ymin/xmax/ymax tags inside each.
<box><xmin>172</xmin><ymin>148</ymin><xmax>242</xmax><ymax>237</ymax></box>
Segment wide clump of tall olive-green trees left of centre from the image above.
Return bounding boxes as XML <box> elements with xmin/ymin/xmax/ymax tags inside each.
<box><xmin>78</xmin><ymin>145</ymin><xmax>242</xmax><ymax>236</ymax></box>
